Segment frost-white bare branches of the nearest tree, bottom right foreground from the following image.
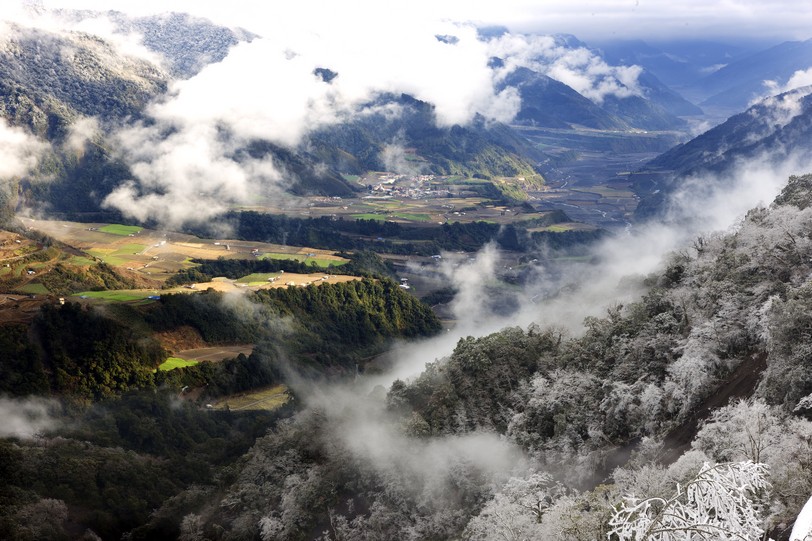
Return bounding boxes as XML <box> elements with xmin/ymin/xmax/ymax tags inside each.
<box><xmin>609</xmin><ymin>461</ymin><xmax>768</xmax><ymax>541</ymax></box>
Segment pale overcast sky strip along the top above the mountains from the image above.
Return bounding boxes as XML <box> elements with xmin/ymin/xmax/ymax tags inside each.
<box><xmin>30</xmin><ymin>0</ymin><xmax>812</xmax><ymax>40</ymax></box>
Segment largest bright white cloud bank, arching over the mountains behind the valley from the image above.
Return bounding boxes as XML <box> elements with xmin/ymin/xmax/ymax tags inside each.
<box><xmin>100</xmin><ymin>14</ymin><xmax>519</xmax><ymax>226</ymax></box>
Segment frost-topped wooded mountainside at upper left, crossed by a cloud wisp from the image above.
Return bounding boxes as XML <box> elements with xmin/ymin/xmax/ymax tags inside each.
<box><xmin>0</xmin><ymin>21</ymin><xmax>170</xmax><ymax>219</ymax></box>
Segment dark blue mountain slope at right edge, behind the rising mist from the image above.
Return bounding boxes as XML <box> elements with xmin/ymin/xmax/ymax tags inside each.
<box><xmin>634</xmin><ymin>87</ymin><xmax>812</xmax><ymax>218</ymax></box>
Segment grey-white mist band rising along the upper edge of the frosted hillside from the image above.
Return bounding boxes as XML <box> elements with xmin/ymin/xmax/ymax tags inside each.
<box><xmin>370</xmin><ymin>146</ymin><xmax>812</xmax><ymax>386</ymax></box>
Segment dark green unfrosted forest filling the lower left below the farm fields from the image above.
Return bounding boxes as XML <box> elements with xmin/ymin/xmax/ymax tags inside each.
<box><xmin>0</xmin><ymin>279</ymin><xmax>439</xmax><ymax>539</ymax></box>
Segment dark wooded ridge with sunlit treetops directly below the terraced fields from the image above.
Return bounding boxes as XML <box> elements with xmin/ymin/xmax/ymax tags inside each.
<box><xmin>0</xmin><ymin>279</ymin><xmax>440</xmax><ymax>400</ymax></box>
